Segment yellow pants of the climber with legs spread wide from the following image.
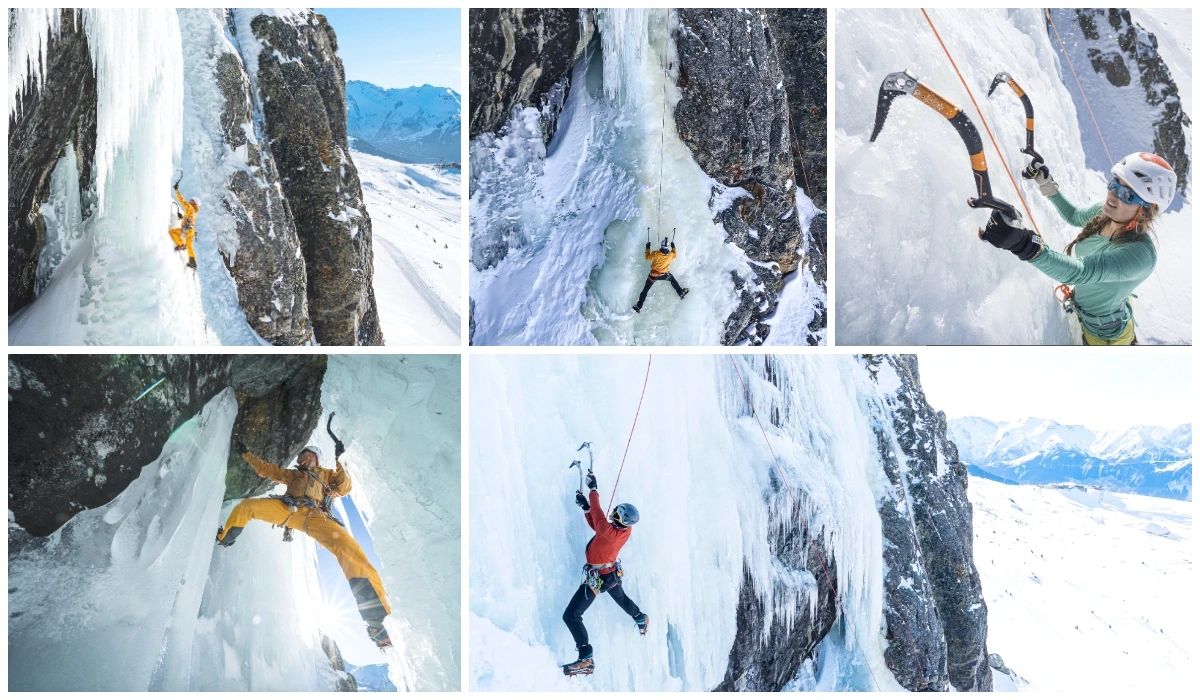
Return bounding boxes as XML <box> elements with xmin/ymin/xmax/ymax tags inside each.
<box><xmin>221</xmin><ymin>498</ymin><xmax>391</xmax><ymax>620</ymax></box>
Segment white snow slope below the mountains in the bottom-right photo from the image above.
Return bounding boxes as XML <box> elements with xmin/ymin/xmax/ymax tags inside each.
<box><xmin>971</xmin><ymin>479</ymin><xmax>1196</xmax><ymax>696</ymax></box>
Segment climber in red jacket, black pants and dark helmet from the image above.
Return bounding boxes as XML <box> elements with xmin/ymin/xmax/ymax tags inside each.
<box><xmin>563</xmin><ymin>472</ymin><xmax>650</xmax><ymax>676</ymax></box>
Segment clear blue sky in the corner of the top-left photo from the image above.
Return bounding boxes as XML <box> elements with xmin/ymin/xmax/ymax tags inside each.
<box><xmin>317</xmin><ymin>7</ymin><xmax>462</xmax><ymax>92</ymax></box>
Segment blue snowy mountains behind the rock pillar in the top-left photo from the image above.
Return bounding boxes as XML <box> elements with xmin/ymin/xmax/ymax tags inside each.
<box><xmin>346</xmin><ymin>80</ymin><xmax>461</xmax><ymax>163</ymax></box>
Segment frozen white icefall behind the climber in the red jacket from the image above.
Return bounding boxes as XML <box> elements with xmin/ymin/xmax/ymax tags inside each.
<box><xmin>469</xmin><ymin>355</ymin><xmax>990</xmax><ymax>690</ymax></box>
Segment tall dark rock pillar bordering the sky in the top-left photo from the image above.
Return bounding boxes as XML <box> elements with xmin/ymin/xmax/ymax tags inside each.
<box><xmin>231</xmin><ymin>13</ymin><xmax>383</xmax><ymax>345</ymax></box>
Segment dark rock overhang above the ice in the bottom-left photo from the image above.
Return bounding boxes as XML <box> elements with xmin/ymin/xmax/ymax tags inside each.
<box><xmin>8</xmin><ymin>354</ymin><xmax>325</xmax><ymax>537</ymax></box>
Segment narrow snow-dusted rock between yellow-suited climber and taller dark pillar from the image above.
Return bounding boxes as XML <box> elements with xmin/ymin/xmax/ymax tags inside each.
<box><xmin>214</xmin><ymin>32</ymin><xmax>312</xmax><ymax>345</ymax></box>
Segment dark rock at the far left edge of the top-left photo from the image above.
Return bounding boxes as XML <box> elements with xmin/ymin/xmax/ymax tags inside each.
<box><xmin>8</xmin><ymin>10</ymin><xmax>96</xmax><ymax>315</ymax></box>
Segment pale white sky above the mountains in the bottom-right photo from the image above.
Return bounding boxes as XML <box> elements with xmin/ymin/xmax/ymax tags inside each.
<box><xmin>917</xmin><ymin>347</ymin><xmax>1192</xmax><ymax>430</ymax></box>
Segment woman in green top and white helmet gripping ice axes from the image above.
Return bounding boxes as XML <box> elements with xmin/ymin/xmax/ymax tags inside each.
<box><xmin>979</xmin><ymin>152</ymin><xmax>1177</xmax><ymax>345</ymax></box>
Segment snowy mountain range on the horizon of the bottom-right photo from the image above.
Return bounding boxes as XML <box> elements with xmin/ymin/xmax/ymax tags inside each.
<box><xmin>949</xmin><ymin>417</ymin><xmax>1192</xmax><ymax>501</ymax></box>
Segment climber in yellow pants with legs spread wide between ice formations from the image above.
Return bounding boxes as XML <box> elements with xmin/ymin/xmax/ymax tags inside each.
<box><xmin>217</xmin><ymin>438</ymin><xmax>391</xmax><ymax>648</ymax></box>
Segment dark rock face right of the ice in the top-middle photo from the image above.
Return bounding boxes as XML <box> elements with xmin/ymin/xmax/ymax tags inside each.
<box><xmin>674</xmin><ymin>10</ymin><xmax>824</xmax><ymax>345</ymax></box>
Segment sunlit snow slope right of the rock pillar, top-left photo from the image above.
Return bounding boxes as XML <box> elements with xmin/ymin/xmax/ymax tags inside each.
<box><xmin>354</xmin><ymin>151</ymin><xmax>462</xmax><ymax>345</ymax></box>
